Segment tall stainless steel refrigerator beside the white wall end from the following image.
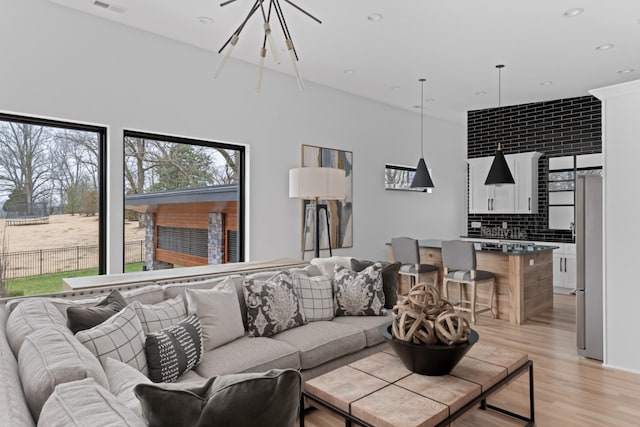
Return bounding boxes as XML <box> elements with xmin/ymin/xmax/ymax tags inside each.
<box><xmin>575</xmin><ymin>175</ymin><xmax>603</xmax><ymax>360</ymax></box>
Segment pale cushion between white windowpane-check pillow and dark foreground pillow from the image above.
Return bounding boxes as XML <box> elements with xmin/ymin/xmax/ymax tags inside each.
<box><xmin>104</xmin><ymin>357</ymin><xmax>151</xmax><ymax>418</ymax></box>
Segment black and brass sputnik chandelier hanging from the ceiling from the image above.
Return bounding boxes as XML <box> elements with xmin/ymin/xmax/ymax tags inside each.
<box><xmin>213</xmin><ymin>0</ymin><xmax>322</xmax><ymax>92</ymax></box>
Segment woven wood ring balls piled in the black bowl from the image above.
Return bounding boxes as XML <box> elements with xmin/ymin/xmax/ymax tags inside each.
<box><xmin>391</xmin><ymin>283</ymin><xmax>471</xmax><ymax>345</ymax></box>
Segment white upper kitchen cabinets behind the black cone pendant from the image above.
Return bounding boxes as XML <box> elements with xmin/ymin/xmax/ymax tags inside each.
<box><xmin>468</xmin><ymin>152</ymin><xmax>542</xmax><ymax>214</ymax></box>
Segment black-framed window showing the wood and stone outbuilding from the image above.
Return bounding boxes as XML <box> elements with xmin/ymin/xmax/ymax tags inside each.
<box><xmin>124</xmin><ymin>131</ymin><xmax>244</xmax><ymax>270</ymax></box>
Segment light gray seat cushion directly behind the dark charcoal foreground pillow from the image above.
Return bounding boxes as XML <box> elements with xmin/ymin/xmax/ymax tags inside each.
<box><xmin>195</xmin><ymin>337</ymin><xmax>300</xmax><ymax>378</ymax></box>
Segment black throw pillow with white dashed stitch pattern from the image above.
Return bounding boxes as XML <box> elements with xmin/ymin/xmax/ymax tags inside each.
<box><xmin>145</xmin><ymin>314</ymin><xmax>204</xmax><ymax>383</ymax></box>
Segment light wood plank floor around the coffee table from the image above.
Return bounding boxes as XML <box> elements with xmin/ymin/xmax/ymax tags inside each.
<box><xmin>298</xmin><ymin>295</ymin><xmax>640</xmax><ymax>427</ymax></box>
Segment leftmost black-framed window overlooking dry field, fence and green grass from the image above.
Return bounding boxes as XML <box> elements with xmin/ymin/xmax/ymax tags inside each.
<box><xmin>0</xmin><ymin>114</ymin><xmax>106</xmax><ymax>296</ymax></box>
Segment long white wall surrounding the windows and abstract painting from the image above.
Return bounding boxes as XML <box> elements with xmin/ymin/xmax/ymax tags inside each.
<box><xmin>0</xmin><ymin>0</ymin><xmax>466</xmax><ymax>272</ymax></box>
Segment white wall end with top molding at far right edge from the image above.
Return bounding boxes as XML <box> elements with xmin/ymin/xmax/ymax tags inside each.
<box><xmin>591</xmin><ymin>80</ymin><xmax>640</xmax><ymax>372</ymax></box>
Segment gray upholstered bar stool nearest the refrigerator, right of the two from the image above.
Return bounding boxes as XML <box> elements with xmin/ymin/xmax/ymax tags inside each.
<box><xmin>442</xmin><ymin>240</ymin><xmax>496</xmax><ymax>324</ymax></box>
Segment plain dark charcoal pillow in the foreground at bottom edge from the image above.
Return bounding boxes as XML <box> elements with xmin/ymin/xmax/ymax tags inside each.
<box><xmin>134</xmin><ymin>369</ymin><xmax>302</xmax><ymax>427</ymax></box>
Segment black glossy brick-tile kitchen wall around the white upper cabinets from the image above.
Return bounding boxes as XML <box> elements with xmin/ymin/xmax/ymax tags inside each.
<box><xmin>467</xmin><ymin>96</ymin><xmax>602</xmax><ymax>243</ymax></box>
